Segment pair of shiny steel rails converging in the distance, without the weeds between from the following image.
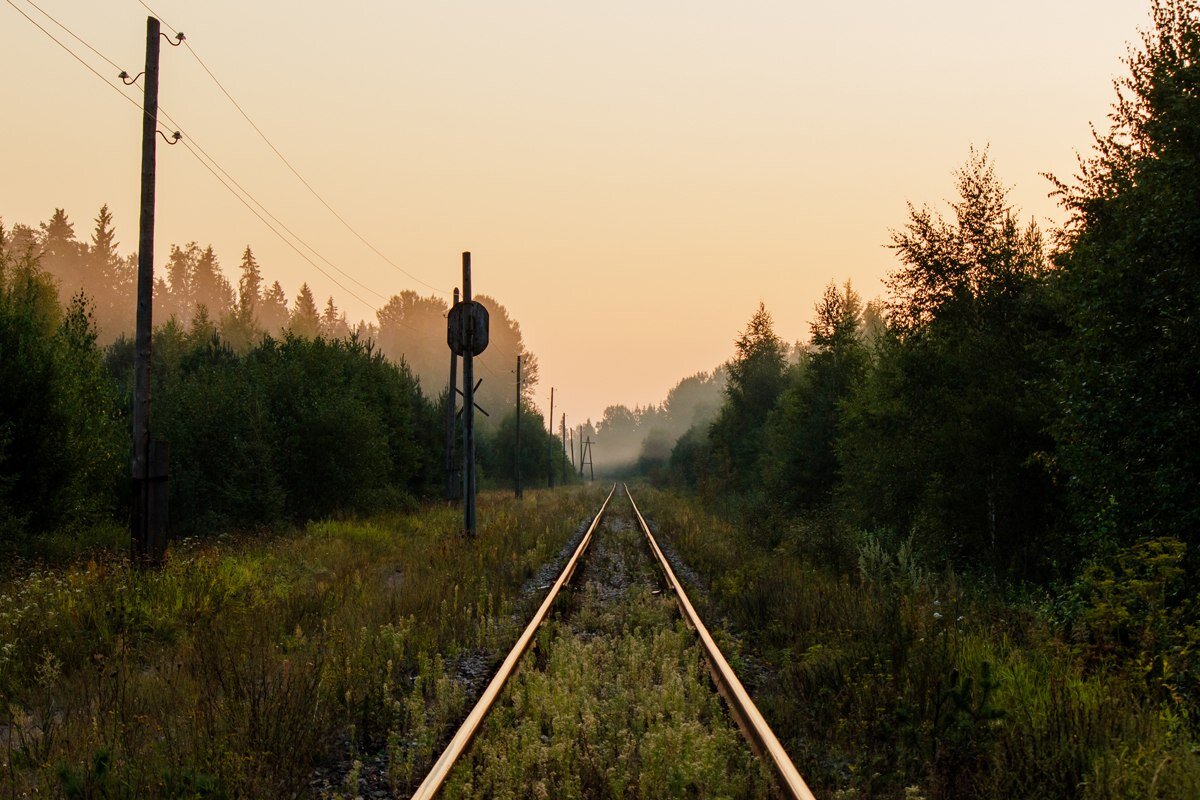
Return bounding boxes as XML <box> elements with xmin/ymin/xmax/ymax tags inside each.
<box><xmin>413</xmin><ymin>485</ymin><xmax>814</xmax><ymax>800</ymax></box>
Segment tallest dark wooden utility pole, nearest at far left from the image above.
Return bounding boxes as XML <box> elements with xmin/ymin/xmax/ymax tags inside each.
<box><xmin>130</xmin><ymin>17</ymin><xmax>167</xmax><ymax>564</ymax></box>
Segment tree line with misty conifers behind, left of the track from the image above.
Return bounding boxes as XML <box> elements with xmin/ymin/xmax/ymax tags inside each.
<box><xmin>0</xmin><ymin>206</ymin><xmax>571</xmax><ymax>549</ymax></box>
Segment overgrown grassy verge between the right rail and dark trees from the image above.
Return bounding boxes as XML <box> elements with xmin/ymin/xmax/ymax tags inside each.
<box><xmin>636</xmin><ymin>489</ymin><xmax>1200</xmax><ymax>800</ymax></box>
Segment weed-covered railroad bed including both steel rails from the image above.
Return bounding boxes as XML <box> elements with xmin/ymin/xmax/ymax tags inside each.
<box><xmin>414</xmin><ymin>487</ymin><xmax>811</xmax><ymax>798</ymax></box>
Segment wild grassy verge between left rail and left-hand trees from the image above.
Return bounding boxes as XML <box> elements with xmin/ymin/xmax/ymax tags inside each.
<box><xmin>0</xmin><ymin>491</ymin><xmax>601</xmax><ymax>798</ymax></box>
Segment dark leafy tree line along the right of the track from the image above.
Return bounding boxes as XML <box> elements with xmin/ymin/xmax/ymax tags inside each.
<box><xmin>665</xmin><ymin>0</ymin><xmax>1200</xmax><ymax>587</ymax></box>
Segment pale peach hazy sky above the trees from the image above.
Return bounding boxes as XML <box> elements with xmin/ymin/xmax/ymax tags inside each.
<box><xmin>7</xmin><ymin>0</ymin><xmax>1148</xmax><ymax>422</ymax></box>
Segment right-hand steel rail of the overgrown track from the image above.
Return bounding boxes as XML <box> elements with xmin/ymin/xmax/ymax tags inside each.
<box><xmin>623</xmin><ymin>485</ymin><xmax>816</xmax><ymax>800</ymax></box>
